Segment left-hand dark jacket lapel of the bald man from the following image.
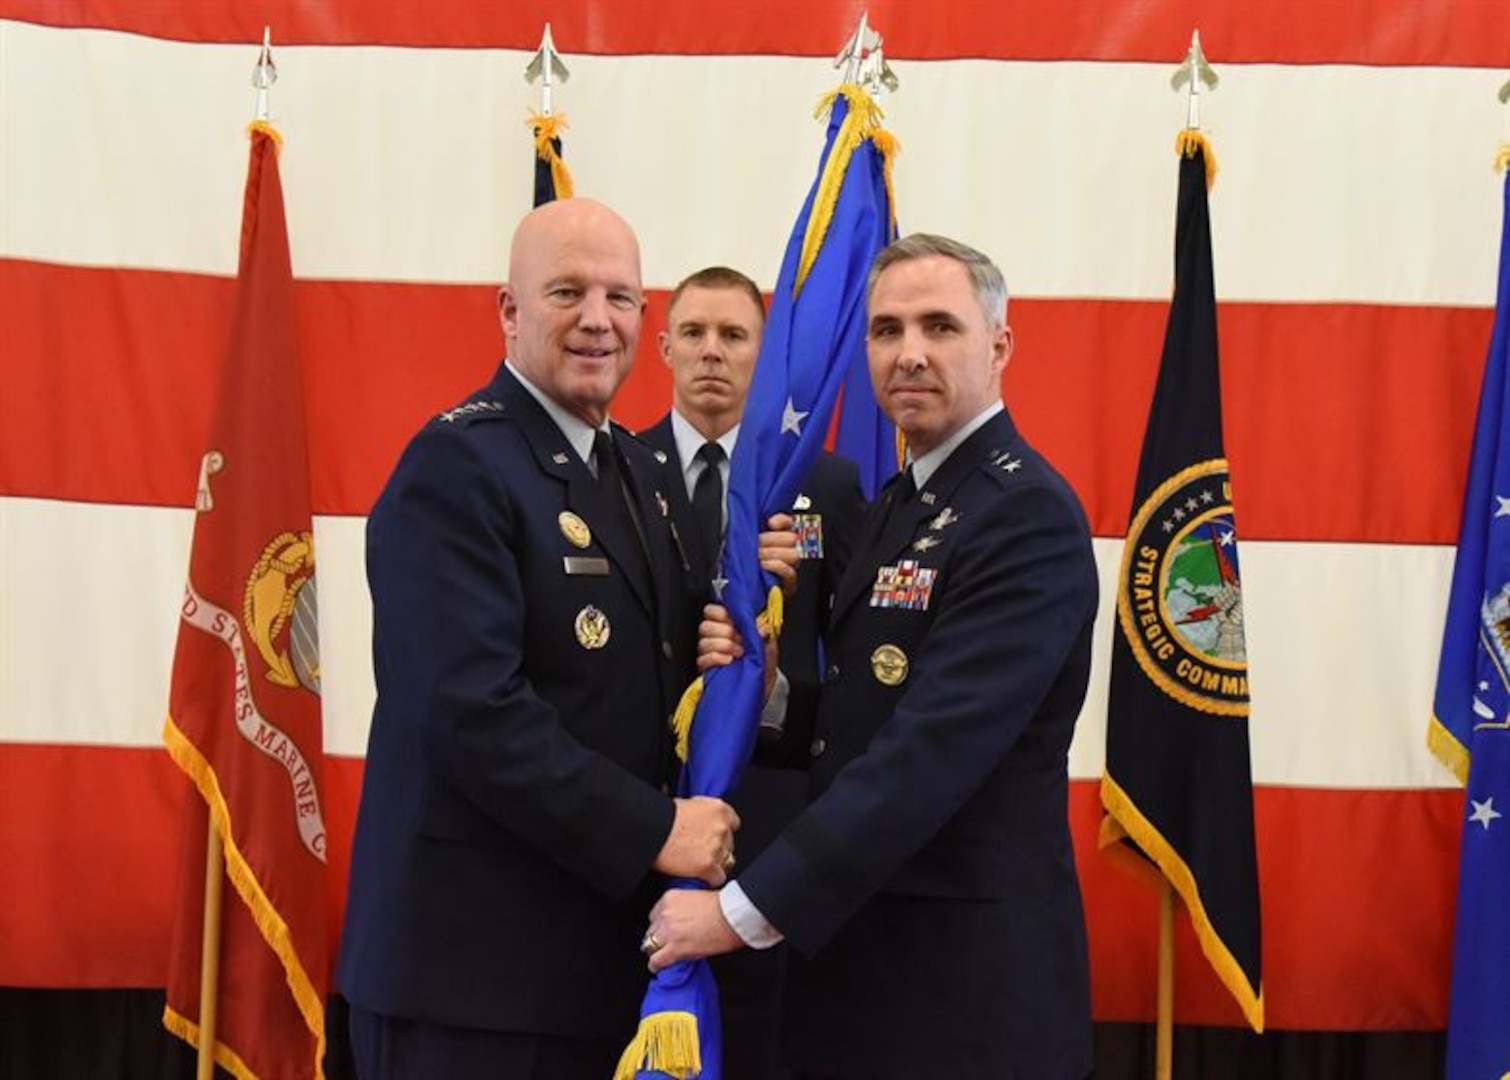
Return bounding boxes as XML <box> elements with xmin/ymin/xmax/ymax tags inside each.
<box><xmin>494</xmin><ymin>369</ymin><xmax>660</xmax><ymax>613</ymax></box>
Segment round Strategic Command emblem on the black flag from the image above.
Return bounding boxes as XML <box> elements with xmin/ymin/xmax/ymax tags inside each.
<box><xmin>1117</xmin><ymin>458</ymin><xmax>1247</xmax><ymax>716</ymax></box>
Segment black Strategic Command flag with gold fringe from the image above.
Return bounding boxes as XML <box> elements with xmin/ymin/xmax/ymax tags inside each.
<box><xmin>1101</xmin><ymin>131</ymin><xmax>1264</xmax><ymax>1032</ymax></box>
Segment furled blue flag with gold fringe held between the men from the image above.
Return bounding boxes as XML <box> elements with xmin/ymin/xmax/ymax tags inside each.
<box><xmin>615</xmin><ymin>12</ymin><xmax>895</xmax><ymax>1080</ymax></box>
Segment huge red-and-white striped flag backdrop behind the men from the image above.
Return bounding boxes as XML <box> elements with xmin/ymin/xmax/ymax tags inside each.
<box><xmin>0</xmin><ymin>0</ymin><xmax>1510</xmax><ymax>1030</ymax></box>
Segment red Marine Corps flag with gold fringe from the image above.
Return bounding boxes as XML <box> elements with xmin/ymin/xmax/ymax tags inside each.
<box><xmin>163</xmin><ymin>124</ymin><xmax>329</xmax><ymax>1080</ymax></box>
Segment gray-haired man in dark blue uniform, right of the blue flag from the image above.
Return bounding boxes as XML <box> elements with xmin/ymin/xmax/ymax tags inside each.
<box><xmin>651</xmin><ymin>236</ymin><xmax>1098</xmax><ymax>1080</ymax></box>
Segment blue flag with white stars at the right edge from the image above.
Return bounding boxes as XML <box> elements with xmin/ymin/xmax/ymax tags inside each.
<box><xmin>1428</xmin><ymin>160</ymin><xmax>1510</xmax><ymax>1080</ymax></box>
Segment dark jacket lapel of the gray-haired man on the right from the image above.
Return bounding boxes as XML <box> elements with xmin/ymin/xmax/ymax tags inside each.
<box><xmin>832</xmin><ymin>409</ymin><xmax>1016</xmax><ymax>625</ymax></box>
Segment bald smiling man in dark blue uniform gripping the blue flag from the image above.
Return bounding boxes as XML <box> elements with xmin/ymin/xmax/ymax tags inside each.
<box><xmin>337</xmin><ymin>199</ymin><xmax>737</xmax><ymax>1080</ymax></box>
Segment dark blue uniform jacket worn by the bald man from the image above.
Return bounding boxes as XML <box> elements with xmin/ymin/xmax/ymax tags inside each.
<box><xmin>337</xmin><ymin>367</ymin><xmax>695</xmax><ymax>1041</ymax></box>
